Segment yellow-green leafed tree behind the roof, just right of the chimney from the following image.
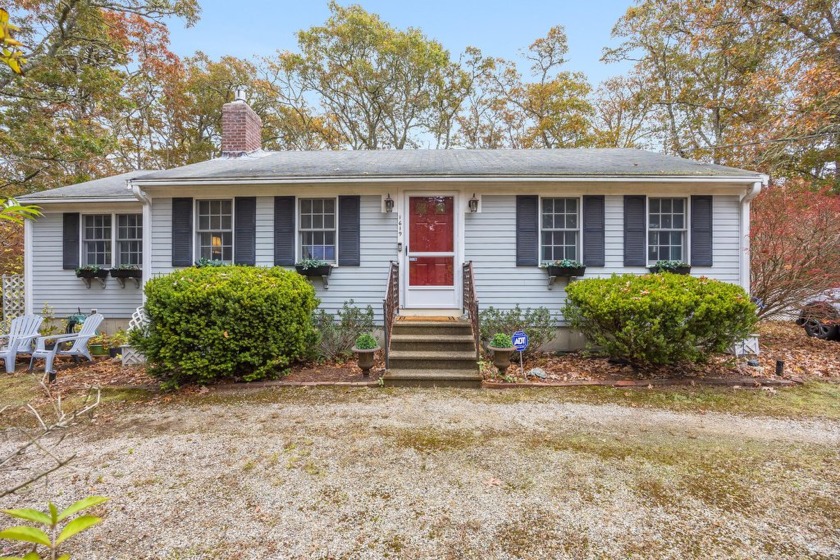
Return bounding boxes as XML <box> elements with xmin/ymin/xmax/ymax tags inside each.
<box><xmin>277</xmin><ymin>2</ymin><xmax>453</xmax><ymax>150</ymax></box>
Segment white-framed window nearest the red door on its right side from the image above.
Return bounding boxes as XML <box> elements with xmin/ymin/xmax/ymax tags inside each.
<box><xmin>540</xmin><ymin>198</ymin><xmax>580</xmax><ymax>261</ymax></box>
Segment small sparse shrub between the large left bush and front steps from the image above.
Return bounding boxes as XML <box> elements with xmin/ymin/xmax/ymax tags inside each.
<box><xmin>307</xmin><ymin>299</ymin><xmax>374</xmax><ymax>360</ymax></box>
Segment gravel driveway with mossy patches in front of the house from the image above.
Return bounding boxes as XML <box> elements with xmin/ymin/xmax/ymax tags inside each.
<box><xmin>0</xmin><ymin>389</ymin><xmax>840</xmax><ymax>560</ymax></box>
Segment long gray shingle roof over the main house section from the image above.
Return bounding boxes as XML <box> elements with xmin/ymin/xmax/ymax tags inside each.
<box><xmin>133</xmin><ymin>148</ymin><xmax>761</xmax><ymax>183</ymax></box>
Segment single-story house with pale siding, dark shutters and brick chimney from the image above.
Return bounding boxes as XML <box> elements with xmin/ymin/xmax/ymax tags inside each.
<box><xmin>22</xmin><ymin>96</ymin><xmax>767</xmax><ymax>348</ymax></box>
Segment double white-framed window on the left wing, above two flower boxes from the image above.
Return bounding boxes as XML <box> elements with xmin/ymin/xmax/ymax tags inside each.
<box><xmin>81</xmin><ymin>214</ymin><xmax>143</xmax><ymax>268</ymax></box>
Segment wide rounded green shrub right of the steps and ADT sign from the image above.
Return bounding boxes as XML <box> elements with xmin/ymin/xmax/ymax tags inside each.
<box><xmin>564</xmin><ymin>274</ymin><xmax>756</xmax><ymax>366</ymax></box>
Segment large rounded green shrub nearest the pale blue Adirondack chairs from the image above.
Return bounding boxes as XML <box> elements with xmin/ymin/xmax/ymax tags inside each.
<box><xmin>131</xmin><ymin>266</ymin><xmax>318</xmax><ymax>386</ymax></box>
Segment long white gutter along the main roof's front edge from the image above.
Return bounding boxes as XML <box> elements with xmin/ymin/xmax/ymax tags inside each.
<box><xmin>130</xmin><ymin>175</ymin><xmax>766</xmax><ymax>187</ymax></box>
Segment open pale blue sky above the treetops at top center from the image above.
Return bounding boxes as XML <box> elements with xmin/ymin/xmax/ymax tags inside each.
<box><xmin>170</xmin><ymin>0</ymin><xmax>632</xmax><ymax>86</ymax></box>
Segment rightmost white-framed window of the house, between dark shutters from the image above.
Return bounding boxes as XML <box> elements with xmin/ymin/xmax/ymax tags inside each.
<box><xmin>648</xmin><ymin>198</ymin><xmax>688</xmax><ymax>263</ymax></box>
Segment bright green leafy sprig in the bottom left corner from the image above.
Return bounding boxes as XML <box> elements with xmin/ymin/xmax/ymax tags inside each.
<box><xmin>0</xmin><ymin>496</ymin><xmax>108</xmax><ymax>560</ymax></box>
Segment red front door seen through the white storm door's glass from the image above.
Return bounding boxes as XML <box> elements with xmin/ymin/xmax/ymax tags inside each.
<box><xmin>408</xmin><ymin>196</ymin><xmax>455</xmax><ymax>288</ymax></box>
